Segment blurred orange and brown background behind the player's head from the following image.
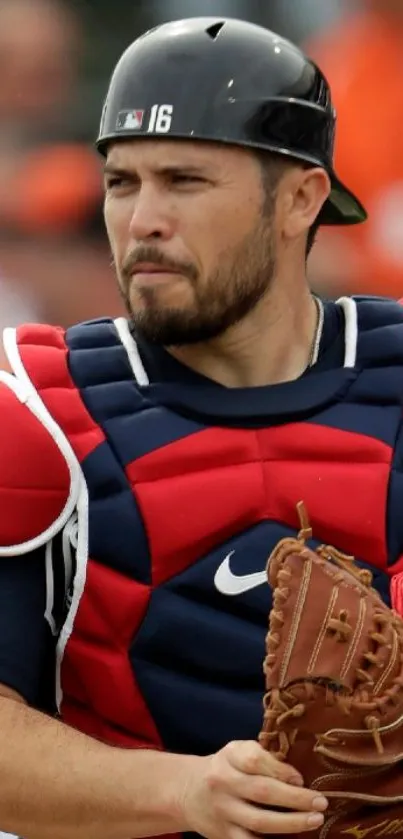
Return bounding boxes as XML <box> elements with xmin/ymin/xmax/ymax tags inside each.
<box><xmin>0</xmin><ymin>0</ymin><xmax>403</xmax><ymax>352</ymax></box>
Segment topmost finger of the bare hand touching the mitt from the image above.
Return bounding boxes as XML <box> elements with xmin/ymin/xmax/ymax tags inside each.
<box><xmin>224</xmin><ymin>740</ymin><xmax>304</xmax><ymax>786</ymax></box>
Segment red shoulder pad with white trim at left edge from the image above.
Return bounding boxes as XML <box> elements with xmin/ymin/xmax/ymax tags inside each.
<box><xmin>0</xmin><ymin>373</ymin><xmax>71</xmax><ymax>556</ymax></box>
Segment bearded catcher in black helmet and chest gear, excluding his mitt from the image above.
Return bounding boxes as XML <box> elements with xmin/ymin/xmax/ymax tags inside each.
<box><xmin>0</xmin><ymin>18</ymin><xmax>403</xmax><ymax>839</ymax></box>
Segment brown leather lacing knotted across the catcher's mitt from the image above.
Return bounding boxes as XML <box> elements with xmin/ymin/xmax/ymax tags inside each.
<box><xmin>259</xmin><ymin>503</ymin><xmax>403</xmax><ymax>760</ymax></box>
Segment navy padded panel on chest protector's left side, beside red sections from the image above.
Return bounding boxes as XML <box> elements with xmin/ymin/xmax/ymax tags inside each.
<box><xmin>66</xmin><ymin>320</ymin><xmax>207</xmax><ymax>583</ymax></box>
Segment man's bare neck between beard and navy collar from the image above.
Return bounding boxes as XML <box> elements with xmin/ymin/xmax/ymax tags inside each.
<box><xmin>166</xmin><ymin>288</ymin><xmax>318</xmax><ymax>388</ymax></box>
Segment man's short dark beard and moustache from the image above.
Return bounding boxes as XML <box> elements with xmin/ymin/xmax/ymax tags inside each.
<box><xmin>115</xmin><ymin>220</ymin><xmax>276</xmax><ymax>346</ymax></box>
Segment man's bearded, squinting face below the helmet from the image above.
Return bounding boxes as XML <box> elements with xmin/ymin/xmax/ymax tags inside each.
<box><xmin>105</xmin><ymin>139</ymin><xmax>275</xmax><ymax>346</ymax></box>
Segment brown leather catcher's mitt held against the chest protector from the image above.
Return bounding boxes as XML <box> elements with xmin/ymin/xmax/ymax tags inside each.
<box><xmin>259</xmin><ymin>504</ymin><xmax>403</xmax><ymax>839</ymax></box>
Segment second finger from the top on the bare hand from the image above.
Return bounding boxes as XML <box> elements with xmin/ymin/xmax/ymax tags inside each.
<box><xmin>231</xmin><ymin>772</ymin><xmax>328</xmax><ymax>812</ymax></box>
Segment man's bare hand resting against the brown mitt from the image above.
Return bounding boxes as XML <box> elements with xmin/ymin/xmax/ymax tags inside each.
<box><xmin>181</xmin><ymin>740</ymin><xmax>327</xmax><ymax>839</ymax></box>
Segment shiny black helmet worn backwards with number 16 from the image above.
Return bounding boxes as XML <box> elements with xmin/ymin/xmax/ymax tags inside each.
<box><xmin>97</xmin><ymin>18</ymin><xmax>366</xmax><ymax>224</ymax></box>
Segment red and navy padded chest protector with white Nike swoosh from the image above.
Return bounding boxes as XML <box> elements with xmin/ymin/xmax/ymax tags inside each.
<box><xmin>5</xmin><ymin>298</ymin><xmax>403</xmax><ymax>754</ymax></box>
